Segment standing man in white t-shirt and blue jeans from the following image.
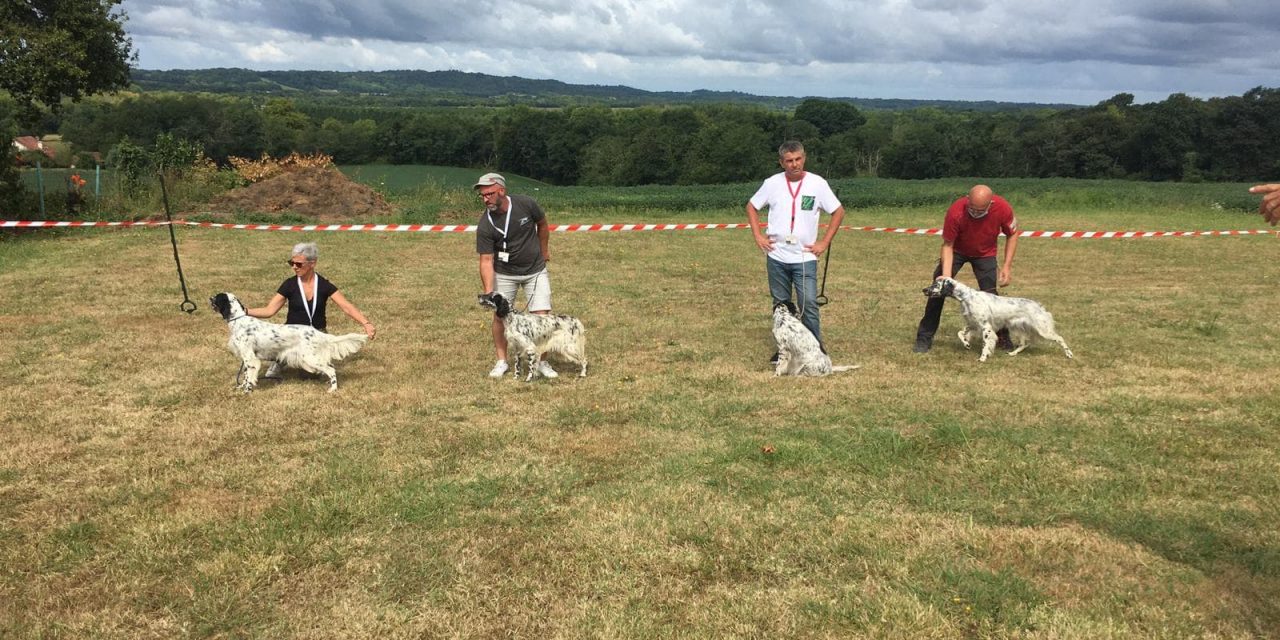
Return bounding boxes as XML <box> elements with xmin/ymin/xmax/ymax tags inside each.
<box><xmin>746</xmin><ymin>141</ymin><xmax>845</xmax><ymax>361</ymax></box>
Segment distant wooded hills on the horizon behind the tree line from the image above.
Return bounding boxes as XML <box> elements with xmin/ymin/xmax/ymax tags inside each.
<box><xmin>131</xmin><ymin>69</ymin><xmax>1080</xmax><ymax>111</ymax></box>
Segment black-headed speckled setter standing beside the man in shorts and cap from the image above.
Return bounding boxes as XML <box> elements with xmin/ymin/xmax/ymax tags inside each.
<box><xmin>479</xmin><ymin>293</ymin><xmax>586</xmax><ymax>383</ymax></box>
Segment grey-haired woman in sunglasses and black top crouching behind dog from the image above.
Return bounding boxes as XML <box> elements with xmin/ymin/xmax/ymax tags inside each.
<box><xmin>246</xmin><ymin>242</ymin><xmax>378</xmax><ymax>343</ymax></box>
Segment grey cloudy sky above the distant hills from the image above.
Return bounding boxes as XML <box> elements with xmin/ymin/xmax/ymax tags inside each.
<box><xmin>122</xmin><ymin>0</ymin><xmax>1280</xmax><ymax>105</ymax></box>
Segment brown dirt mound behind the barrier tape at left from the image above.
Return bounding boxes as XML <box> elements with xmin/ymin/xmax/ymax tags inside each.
<box><xmin>200</xmin><ymin>166</ymin><xmax>396</xmax><ymax>223</ymax></box>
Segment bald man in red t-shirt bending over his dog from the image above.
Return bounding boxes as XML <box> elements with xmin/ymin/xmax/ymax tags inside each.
<box><xmin>911</xmin><ymin>184</ymin><xmax>1018</xmax><ymax>353</ymax></box>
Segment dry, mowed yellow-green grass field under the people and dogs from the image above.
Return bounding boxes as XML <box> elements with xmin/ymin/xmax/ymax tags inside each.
<box><xmin>0</xmin><ymin>203</ymin><xmax>1280</xmax><ymax>639</ymax></box>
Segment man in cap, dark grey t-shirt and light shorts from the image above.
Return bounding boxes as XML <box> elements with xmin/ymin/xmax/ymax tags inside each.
<box><xmin>475</xmin><ymin>173</ymin><xmax>556</xmax><ymax>378</ymax></box>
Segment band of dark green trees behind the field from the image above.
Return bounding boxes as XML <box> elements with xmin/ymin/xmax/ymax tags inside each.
<box><xmin>10</xmin><ymin>87</ymin><xmax>1280</xmax><ymax>186</ymax></box>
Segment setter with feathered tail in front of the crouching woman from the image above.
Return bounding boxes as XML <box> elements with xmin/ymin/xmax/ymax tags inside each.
<box><xmin>209</xmin><ymin>293</ymin><xmax>369</xmax><ymax>393</ymax></box>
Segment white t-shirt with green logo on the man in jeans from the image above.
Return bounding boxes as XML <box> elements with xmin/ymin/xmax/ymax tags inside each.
<box><xmin>751</xmin><ymin>172</ymin><xmax>840</xmax><ymax>264</ymax></box>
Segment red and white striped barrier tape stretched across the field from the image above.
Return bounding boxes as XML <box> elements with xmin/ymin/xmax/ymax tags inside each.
<box><xmin>0</xmin><ymin>220</ymin><xmax>1280</xmax><ymax>239</ymax></box>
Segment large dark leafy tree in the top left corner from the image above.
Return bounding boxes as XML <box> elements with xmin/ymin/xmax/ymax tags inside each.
<box><xmin>0</xmin><ymin>0</ymin><xmax>137</xmax><ymax>122</ymax></box>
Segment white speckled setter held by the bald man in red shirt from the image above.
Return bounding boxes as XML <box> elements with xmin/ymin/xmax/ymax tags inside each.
<box><xmin>924</xmin><ymin>278</ymin><xmax>1071</xmax><ymax>362</ymax></box>
